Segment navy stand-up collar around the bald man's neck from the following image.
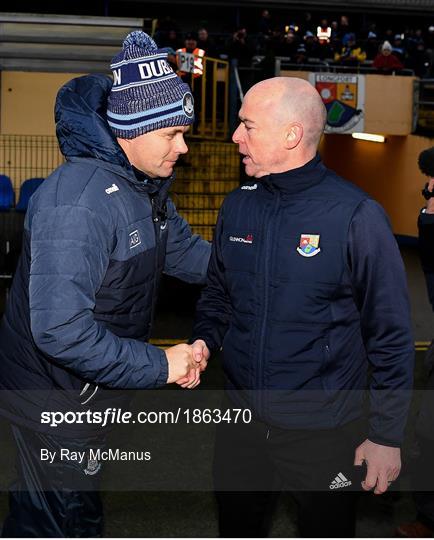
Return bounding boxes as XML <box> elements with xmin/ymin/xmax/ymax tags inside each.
<box><xmin>262</xmin><ymin>153</ymin><xmax>327</xmax><ymax>194</ymax></box>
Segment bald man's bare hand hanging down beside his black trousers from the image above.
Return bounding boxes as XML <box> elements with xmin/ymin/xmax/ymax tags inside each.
<box><xmin>354</xmin><ymin>439</ymin><xmax>401</xmax><ymax>495</ymax></box>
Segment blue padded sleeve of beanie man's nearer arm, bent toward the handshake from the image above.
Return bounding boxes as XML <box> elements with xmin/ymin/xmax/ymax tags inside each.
<box><xmin>29</xmin><ymin>206</ymin><xmax>168</xmax><ymax>388</ymax></box>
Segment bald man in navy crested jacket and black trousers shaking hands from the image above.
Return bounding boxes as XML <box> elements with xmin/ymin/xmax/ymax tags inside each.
<box><xmin>193</xmin><ymin>78</ymin><xmax>413</xmax><ymax>537</ymax></box>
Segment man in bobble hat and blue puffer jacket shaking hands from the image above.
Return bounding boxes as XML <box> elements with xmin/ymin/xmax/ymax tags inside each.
<box><xmin>0</xmin><ymin>32</ymin><xmax>210</xmax><ymax>537</ymax></box>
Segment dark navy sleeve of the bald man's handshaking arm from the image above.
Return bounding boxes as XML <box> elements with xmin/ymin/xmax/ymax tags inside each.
<box><xmin>190</xmin><ymin>206</ymin><xmax>232</xmax><ymax>350</ymax></box>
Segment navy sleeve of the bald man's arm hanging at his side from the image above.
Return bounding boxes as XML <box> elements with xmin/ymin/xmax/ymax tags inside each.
<box><xmin>349</xmin><ymin>200</ymin><xmax>414</xmax><ymax>446</ymax></box>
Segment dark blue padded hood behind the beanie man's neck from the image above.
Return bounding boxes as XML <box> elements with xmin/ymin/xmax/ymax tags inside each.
<box><xmin>54</xmin><ymin>74</ymin><xmax>130</xmax><ymax>168</ymax></box>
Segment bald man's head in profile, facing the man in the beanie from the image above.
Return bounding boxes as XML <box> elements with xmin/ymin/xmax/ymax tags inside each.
<box><xmin>232</xmin><ymin>77</ymin><xmax>326</xmax><ymax>178</ymax></box>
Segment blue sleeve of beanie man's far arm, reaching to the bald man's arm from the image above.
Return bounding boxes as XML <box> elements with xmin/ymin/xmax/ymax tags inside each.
<box><xmin>164</xmin><ymin>199</ymin><xmax>211</xmax><ymax>283</ymax></box>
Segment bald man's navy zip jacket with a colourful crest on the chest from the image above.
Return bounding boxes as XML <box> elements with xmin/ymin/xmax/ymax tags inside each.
<box><xmin>193</xmin><ymin>156</ymin><xmax>414</xmax><ymax>446</ymax></box>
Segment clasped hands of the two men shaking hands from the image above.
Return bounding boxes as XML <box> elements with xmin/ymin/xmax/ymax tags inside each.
<box><xmin>166</xmin><ymin>339</ymin><xmax>210</xmax><ymax>388</ymax></box>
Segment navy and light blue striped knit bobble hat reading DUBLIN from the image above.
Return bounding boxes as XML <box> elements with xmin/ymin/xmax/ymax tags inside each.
<box><xmin>107</xmin><ymin>31</ymin><xmax>194</xmax><ymax>139</ymax></box>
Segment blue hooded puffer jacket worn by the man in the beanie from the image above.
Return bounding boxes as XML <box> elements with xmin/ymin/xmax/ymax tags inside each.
<box><xmin>0</xmin><ymin>75</ymin><xmax>210</xmax><ymax>428</ymax></box>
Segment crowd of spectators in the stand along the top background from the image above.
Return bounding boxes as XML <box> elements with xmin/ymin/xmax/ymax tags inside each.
<box><xmin>155</xmin><ymin>9</ymin><xmax>434</xmax><ymax>78</ymax></box>
